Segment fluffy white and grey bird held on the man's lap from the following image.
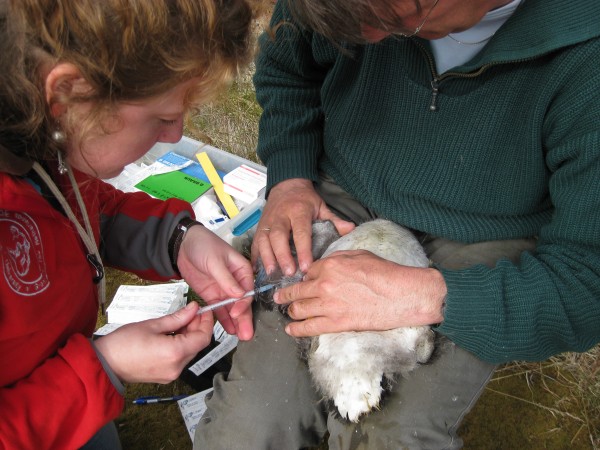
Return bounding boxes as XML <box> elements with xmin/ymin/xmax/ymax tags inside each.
<box><xmin>257</xmin><ymin>219</ymin><xmax>434</xmax><ymax>422</ymax></box>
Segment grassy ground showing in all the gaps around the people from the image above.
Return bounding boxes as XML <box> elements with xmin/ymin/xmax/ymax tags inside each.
<box><xmin>100</xmin><ymin>8</ymin><xmax>600</xmax><ymax>450</ymax></box>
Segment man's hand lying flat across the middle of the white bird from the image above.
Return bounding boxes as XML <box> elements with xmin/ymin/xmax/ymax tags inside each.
<box><xmin>274</xmin><ymin>250</ymin><xmax>447</xmax><ymax>337</ymax></box>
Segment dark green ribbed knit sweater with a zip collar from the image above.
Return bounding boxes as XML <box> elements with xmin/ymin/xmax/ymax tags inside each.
<box><xmin>254</xmin><ymin>0</ymin><xmax>600</xmax><ymax>363</ymax></box>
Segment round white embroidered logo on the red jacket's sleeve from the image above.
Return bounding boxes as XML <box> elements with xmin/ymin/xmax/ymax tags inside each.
<box><xmin>0</xmin><ymin>209</ymin><xmax>50</xmax><ymax>296</ymax></box>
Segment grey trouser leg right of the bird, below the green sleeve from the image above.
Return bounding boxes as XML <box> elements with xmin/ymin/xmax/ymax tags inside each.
<box><xmin>328</xmin><ymin>337</ymin><xmax>495</xmax><ymax>450</ymax></box>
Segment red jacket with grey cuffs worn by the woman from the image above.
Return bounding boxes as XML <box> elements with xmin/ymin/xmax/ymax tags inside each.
<box><xmin>0</xmin><ymin>169</ymin><xmax>192</xmax><ymax>449</ymax></box>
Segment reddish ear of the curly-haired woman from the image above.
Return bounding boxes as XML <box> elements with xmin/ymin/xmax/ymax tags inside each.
<box><xmin>45</xmin><ymin>63</ymin><xmax>92</xmax><ymax>118</ymax></box>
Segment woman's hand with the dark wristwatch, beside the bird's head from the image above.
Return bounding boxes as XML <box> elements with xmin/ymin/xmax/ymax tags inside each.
<box><xmin>177</xmin><ymin>226</ymin><xmax>254</xmax><ymax>341</ymax></box>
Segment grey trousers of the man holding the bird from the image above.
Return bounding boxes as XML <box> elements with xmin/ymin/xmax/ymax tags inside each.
<box><xmin>194</xmin><ymin>177</ymin><xmax>535</xmax><ymax>450</ymax></box>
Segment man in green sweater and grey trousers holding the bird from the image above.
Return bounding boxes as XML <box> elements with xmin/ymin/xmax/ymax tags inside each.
<box><xmin>196</xmin><ymin>0</ymin><xmax>600</xmax><ymax>449</ymax></box>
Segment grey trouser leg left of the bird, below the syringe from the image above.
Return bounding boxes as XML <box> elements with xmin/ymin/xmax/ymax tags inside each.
<box><xmin>194</xmin><ymin>304</ymin><xmax>327</xmax><ymax>450</ymax></box>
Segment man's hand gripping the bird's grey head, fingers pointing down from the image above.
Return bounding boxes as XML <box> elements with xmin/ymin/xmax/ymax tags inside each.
<box><xmin>252</xmin><ymin>178</ymin><xmax>354</xmax><ymax>276</ymax></box>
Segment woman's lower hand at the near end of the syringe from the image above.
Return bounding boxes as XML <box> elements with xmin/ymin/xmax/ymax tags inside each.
<box><xmin>95</xmin><ymin>302</ymin><xmax>214</xmax><ymax>384</ymax></box>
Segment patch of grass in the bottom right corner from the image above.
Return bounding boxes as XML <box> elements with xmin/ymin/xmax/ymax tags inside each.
<box><xmin>461</xmin><ymin>352</ymin><xmax>600</xmax><ymax>449</ymax></box>
